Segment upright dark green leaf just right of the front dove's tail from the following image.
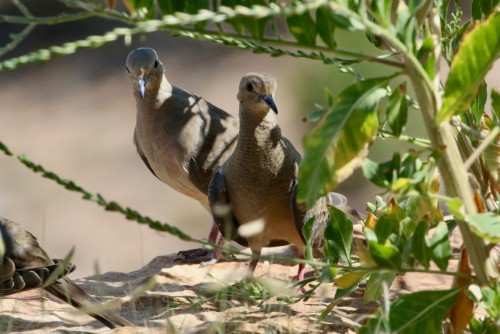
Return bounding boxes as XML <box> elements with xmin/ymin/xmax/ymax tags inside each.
<box><xmin>324</xmin><ymin>207</ymin><xmax>353</xmax><ymax>265</ymax></box>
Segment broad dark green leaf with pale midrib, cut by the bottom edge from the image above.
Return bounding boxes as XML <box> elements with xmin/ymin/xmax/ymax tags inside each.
<box><xmin>389</xmin><ymin>288</ymin><xmax>461</xmax><ymax>334</ymax></box>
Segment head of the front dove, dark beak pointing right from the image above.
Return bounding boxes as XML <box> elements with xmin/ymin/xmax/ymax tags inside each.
<box><xmin>238</xmin><ymin>73</ymin><xmax>278</xmax><ymax>114</ymax></box>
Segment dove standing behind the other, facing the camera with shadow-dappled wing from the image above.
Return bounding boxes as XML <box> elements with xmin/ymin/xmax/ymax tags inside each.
<box><xmin>126</xmin><ymin>48</ymin><xmax>238</xmax><ymax>262</ymax></box>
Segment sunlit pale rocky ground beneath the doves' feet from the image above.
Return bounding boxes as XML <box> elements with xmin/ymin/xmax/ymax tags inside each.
<box><xmin>0</xmin><ymin>248</ymin><xmax>460</xmax><ymax>333</ymax></box>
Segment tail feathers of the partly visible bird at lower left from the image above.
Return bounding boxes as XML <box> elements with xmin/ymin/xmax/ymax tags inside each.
<box><xmin>44</xmin><ymin>277</ymin><xmax>134</xmax><ymax>328</ymax></box>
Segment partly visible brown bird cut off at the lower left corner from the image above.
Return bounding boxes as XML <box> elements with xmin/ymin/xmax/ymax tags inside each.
<box><xmin>0</xmin><ymin>217</ymin><xmax>134</xmax><ymax>328</ymax></box>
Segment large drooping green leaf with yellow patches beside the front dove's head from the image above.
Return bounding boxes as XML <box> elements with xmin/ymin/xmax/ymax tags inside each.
<box><xmin>298</xmin><ymin>78</ymin><xmax>389</xmax><ymax>205</ymax></box>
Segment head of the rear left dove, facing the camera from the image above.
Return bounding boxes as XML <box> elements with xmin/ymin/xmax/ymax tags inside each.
<box><xmin>125</xmin><ymin>48</ymin><xmax>163</xmax><ymax>98</ymax></box>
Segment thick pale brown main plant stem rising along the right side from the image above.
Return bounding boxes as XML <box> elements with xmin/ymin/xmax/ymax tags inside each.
<box><xmin>330</xmin><ymin>3</ymin><xmax>488</xmax><ymax>285</ymax></box>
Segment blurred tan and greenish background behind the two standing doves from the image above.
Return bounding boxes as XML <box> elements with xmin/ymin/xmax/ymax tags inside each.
<box><xmin>0</xmin><ymin>1</ymin><xmax>500</xmax><ymax>277</ymax></box>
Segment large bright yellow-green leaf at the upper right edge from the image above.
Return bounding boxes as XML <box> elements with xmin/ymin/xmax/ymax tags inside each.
<box><xmin>436</xmin><ymin>11</ymin><xmax>500</xmax><ymax>124</ymax></box>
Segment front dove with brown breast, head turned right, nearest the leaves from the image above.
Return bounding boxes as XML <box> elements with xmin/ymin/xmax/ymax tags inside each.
<box><xmin>208</xmin><ymin>73</ymin><xmax>352</xmax><ymax>281</ymax></box>
